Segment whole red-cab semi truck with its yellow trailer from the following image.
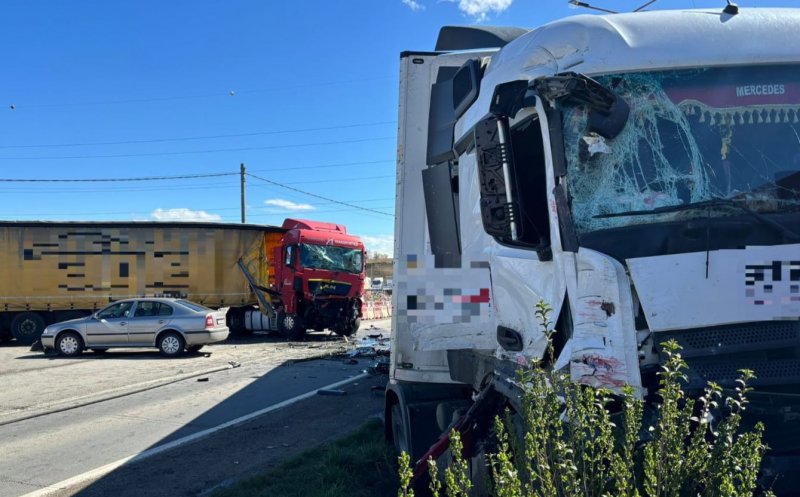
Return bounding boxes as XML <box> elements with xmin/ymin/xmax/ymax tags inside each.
<box><xmin>0</xmin><ymin>219</ymin><xmax>365</xmax><ymax>344</ymax></box>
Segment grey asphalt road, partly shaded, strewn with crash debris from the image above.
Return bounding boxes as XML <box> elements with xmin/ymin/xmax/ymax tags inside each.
<box><xmin>0</xmin><ymin>320</ymin><xmax>389</xmax><ymax>497</ymax></box>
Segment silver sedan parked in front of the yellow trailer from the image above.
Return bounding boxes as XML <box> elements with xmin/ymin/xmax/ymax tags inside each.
<box><xmin>42</xmin><ymin>298</ymin><xmax>229</xmax><ymax>357</ymax></box>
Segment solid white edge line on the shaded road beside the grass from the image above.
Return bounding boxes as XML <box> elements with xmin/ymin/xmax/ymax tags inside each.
<box><xmin>21</xmin><ymin>373</ymin><xmax>369</xmax><ymax>497</ymax></box>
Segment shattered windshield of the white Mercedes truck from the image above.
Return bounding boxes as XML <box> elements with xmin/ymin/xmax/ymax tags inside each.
<box><xmin>563</xmin><ymin>65</ymin><xmax>800</xmax><ymax>233</ymax></box>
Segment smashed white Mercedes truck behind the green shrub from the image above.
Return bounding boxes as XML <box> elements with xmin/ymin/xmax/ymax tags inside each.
<box><xmin>385</xmin><ymin>6</ymin><xmax>800</xmax><ymax>486</ymax></box>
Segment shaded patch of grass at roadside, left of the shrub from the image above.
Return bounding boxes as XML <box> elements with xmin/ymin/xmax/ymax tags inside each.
<box><xmin>212</xmin><ymin>419</ymin><xmax>398</xmax><ymax>497</ymax></box>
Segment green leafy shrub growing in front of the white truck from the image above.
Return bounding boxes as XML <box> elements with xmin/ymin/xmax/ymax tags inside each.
<box><xmin>398</xmin><ymin>302</ymin><xmax>772</xmax><ymax>497</ymax></box>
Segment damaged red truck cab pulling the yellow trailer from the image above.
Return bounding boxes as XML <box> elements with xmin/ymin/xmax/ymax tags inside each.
<box><xmin>272</xmin><ymin>219</ymin><xmax>366</xmax><ymax>338</ymax></box>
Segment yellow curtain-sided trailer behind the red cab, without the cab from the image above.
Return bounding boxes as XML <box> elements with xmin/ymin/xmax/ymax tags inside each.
<box><xmin>0</xmin><ymin>222</ymin><xmax>286</xmax><ymax>343</ymax></box>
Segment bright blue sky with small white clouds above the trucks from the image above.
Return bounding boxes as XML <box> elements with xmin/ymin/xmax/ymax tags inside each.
<box><xmin>0</xmin><ymin>0</ymin><xmax>794</xmax><ymax>253</ymax></box>
